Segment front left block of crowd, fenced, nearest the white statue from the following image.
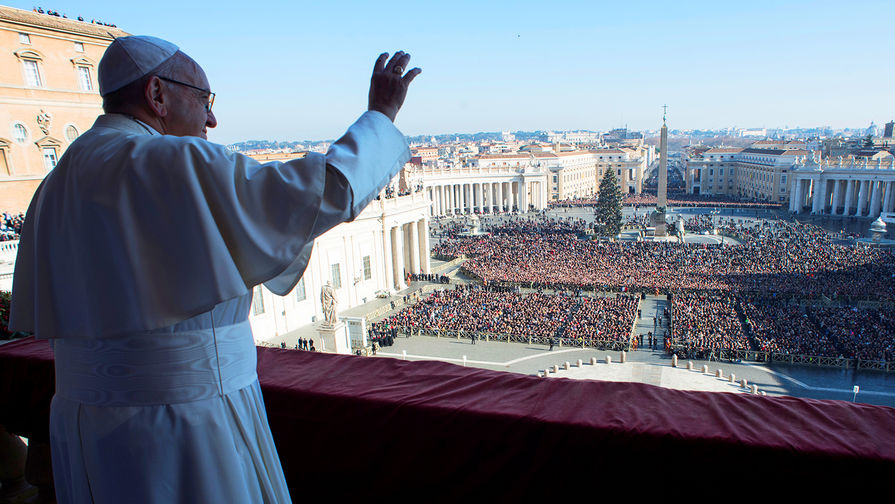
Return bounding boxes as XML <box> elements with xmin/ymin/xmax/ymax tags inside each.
<box><xmin>373</xmin><ymin>285</ymin><xmax>639</xmax><ymax>342</ymax></box>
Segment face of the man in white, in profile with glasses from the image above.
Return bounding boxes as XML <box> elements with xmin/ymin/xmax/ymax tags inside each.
<box><xmin>162</xmin><ymin>56</ymin><xmax>218</xmax><ymax>140</ymax></box>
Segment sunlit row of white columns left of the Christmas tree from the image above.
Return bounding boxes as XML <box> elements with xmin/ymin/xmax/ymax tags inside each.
<box><xmin>426</xmin><ymin>179</ymin><xmax>547</xmax><ymax>216</ymax></box>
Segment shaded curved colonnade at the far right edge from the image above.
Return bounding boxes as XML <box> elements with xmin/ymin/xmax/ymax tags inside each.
<box><xmin>789</xmin><ymin>172</ymin><xmax>895</xmax><ymax>218</ymax></box>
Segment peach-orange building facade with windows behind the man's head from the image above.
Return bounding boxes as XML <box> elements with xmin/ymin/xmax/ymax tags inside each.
<box><xmin>0</xmin><ymin>6</ymin><xmax>127</xmax><ymax>212</ymax></box>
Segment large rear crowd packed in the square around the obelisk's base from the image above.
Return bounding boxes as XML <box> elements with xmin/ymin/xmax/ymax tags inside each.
<box><xmin>434</xmin><ymin>220</ymin><xmax>895</xmax><ymax>300</ymax></box>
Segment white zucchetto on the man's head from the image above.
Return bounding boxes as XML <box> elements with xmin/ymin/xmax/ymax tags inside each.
<box><xmin>97</xmin><ymin>35</ymin><xmax>178</xmax><ymax>96</ymax></box>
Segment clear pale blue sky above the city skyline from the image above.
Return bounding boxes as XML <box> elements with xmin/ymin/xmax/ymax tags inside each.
<box><xmin>7</xmin><ymin>0</ymin><xmax>895</xmax><ymax>143</ymax></box>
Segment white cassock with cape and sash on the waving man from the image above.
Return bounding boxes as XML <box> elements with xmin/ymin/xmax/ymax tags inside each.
<box><xmin>10</xmin><ymin>112</ymin><xmax>410</xmax><ymax>503</ymax></box>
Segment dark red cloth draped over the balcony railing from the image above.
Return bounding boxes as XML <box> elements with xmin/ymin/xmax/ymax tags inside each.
<box><xmin>0</xmin><ymin>339</ymin><xmax>895</xmax><ymax>501</ymax></box>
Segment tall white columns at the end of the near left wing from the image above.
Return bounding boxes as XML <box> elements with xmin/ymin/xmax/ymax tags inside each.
<box><xmin>382</xmin><ymin>218</ymin><xmax>432</xmax><ymax>290</ymax></box>
